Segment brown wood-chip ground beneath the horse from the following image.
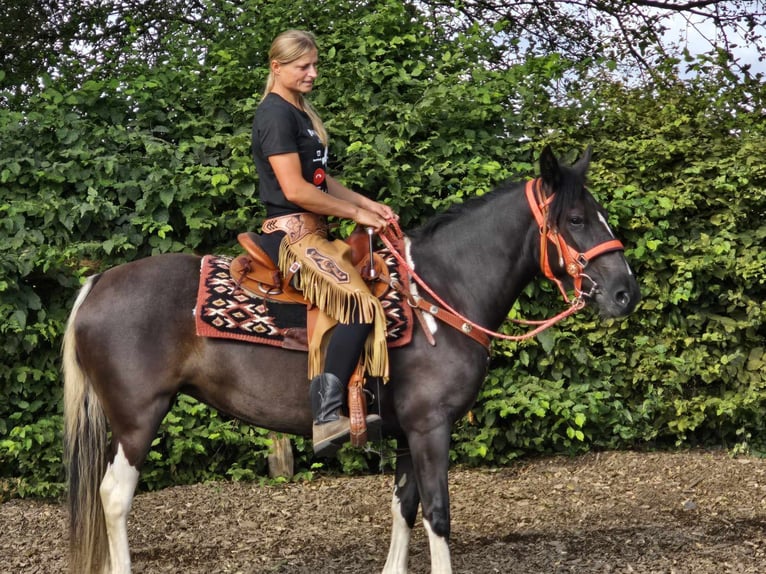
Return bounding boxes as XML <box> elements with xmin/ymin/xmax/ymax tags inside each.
<box><xmin>0</xmin><ymin>452</ymin><xmax>766</xmax><ymax>574</ymax></box>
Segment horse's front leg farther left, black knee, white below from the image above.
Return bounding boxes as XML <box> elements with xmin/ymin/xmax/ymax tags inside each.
<box><xmin>383</xmin><ymin>450</ymin><xmax>420</xmax><ymax>574</ymax></box>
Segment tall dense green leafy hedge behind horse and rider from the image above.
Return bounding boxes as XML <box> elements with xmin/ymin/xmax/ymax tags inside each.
<box><xmin>0</xmin><ymin>0</ymin><xmax>766</xmax><ymax>497</ymax></box>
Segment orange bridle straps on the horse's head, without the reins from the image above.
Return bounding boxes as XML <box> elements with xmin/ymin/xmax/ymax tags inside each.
<box><xmin>526</xmin><ymin>178</ymin><xmax>625</xmax><ymax>303</ymax></box>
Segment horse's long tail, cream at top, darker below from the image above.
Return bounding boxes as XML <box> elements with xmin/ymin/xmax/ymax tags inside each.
<box><xmin>62</xmin><ymin>277</ymin><xmax>109</xmax><ymax>574</ymax></box>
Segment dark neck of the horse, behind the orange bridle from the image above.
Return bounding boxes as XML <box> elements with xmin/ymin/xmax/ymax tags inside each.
<box><xmin>411</xmin><ymin>192</ymin><xmax>538</xmax><ymax>329</ymax></box>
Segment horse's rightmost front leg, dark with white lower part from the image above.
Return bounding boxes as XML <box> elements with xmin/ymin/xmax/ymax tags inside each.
<box><xmin>408</xmin><ymin>424</ymin><xmax>452</xmax><ymax>574</ymax></box>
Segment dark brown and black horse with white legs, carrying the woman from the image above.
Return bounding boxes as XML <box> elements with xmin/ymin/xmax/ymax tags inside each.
<box><xmin>62</xmin><ymin>146</ymin><xmax>640</xmax><ymax>574</ymax></box>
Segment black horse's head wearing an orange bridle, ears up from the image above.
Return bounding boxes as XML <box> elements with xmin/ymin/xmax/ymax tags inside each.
<box><xmin>538</xmin><ymin>147</ymin><xmax>641</xmax><ymax>317</ymax></box>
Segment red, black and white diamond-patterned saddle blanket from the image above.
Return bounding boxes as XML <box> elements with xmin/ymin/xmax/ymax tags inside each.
<box><xmin>194</xmin><ymin>255</ymin><xmax>413</xmax><ymax>349</ymax></box>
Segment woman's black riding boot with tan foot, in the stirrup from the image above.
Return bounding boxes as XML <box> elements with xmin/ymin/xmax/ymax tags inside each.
<box><xmin>309</xmin><ymin>373</ymin><xmax>381</xmax><ymax>457</ymax></box>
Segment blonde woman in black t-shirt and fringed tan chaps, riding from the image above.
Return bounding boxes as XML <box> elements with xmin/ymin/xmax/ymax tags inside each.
<box><xmin>253</xmin><ymin>30</ymin><xmax>397</xmax><ymax>456</ymax></box>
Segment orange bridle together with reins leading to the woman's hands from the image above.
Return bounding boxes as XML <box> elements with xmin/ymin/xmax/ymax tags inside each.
<box><xmin>378</xmin><ymin>179</ymin><xmax>624</xmax><ymax>349</ymax></box>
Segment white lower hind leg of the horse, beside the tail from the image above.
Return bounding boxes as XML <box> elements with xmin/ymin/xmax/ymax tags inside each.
<box><xmin>99</xmin><ymin>444</ymin><xmax>138</xmax><ymax>574</ymax></box>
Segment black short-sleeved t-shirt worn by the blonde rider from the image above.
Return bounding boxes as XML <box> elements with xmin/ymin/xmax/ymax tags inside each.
<box><xmin>253</xmin><ymin>93</ymin><xmax>327</xmax><ymax>217</ymax></box>
